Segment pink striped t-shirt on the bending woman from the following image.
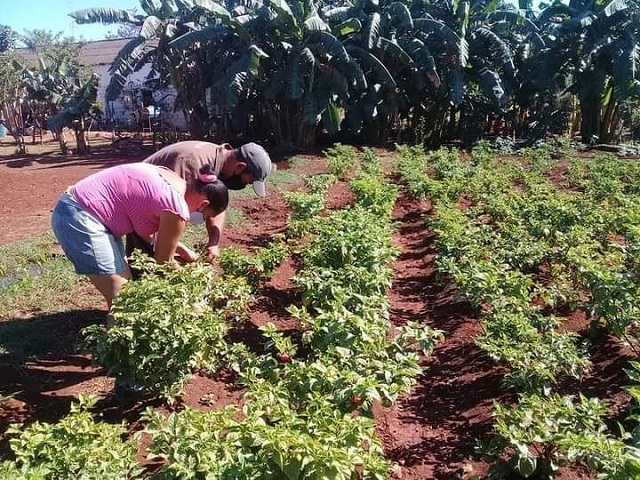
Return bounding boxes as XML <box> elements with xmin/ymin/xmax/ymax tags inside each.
<box><xmin>73</xmin><ymin>163</ymin><xmax>189</xmax><ymax>238</ymax></box>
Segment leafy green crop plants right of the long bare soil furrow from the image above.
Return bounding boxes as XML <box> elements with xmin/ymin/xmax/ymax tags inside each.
<box><xmin>398</xmin><ymin>144</ymin><xmax>640</xmax><ymax>479</ymax></box>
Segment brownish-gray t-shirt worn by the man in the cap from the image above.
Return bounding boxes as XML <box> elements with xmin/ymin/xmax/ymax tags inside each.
<box><xmin>144</xmin><ymin>140</ymin><xmax>225</xmax><ymax>182</ymax></box>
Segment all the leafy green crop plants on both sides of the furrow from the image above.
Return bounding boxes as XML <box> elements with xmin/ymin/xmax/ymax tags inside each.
<box><xmin>6</xmin><ymin>144</ymin><xmax>640</xmax><ymax>480</ymax></box>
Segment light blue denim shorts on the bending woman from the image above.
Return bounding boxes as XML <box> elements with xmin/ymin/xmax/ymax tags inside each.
<box><xmin>51</xmin><ymin>192</ymin><xmax>127</xmax><ymax>275</ymax></box>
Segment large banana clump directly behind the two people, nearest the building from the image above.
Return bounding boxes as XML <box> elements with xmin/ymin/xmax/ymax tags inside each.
<box><xmin>172</xmin><ymin>0</ymin><xmax>364</xmax><ymax>147</ymax></box>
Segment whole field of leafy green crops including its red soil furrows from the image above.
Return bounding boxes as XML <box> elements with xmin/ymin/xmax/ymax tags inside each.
<box><xmin>0</xmin><ymin>143</ymin><xmax>640</xmax><ymax>480</ymax></box>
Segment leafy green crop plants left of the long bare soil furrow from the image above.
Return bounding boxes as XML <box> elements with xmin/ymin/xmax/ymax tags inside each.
<box><xmin>0</xmin><ymin>146</ymin><xmax>442</xmax><ymax>480</ymax></box>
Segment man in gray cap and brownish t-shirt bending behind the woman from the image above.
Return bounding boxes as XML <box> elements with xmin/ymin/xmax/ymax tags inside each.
<box><xmin>127</xmin><ymin>140</ymin><xmax>273</xmax><ymax>262</ymax></box>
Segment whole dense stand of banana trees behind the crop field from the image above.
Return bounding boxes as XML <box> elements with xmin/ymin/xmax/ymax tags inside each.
<box><xmin>71</xmin><ymin>0</ymin><xmax>640</xmax><ymax>149</ymax></box>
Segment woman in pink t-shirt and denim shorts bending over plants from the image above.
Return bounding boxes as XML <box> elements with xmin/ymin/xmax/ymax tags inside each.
<box><xmin>51</xmin><ymin>163</ymin><xmax>229</xmax><ymax>308</ymax></box>
